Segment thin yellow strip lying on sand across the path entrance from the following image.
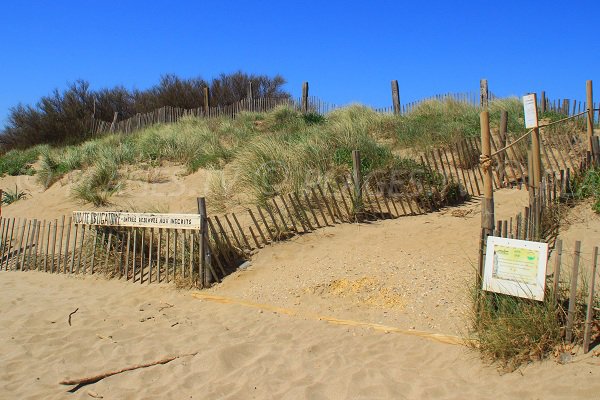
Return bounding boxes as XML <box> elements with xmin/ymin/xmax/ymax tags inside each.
<box><xmin>192</xmin><ymin>292</ymin><xmax>468</xmax><ymax>345</ymax></box>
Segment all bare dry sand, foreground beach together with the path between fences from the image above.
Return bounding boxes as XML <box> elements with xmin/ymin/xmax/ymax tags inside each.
<box><xmin>0</xmin><ymin>191</ymin><xmax>600</xmax><ymax>399</ymax></box>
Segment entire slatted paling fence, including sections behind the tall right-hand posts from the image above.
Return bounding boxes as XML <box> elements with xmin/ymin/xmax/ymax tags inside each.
<box><xmin>0</xmin><ymin>119</ymin><xmax>590</xmax><ymax>286</ymax></box>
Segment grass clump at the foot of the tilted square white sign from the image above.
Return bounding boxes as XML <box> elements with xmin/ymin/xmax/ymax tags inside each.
<box><xmin>470</xmin><ymin>269</ymin><xmax>599</xmax><ymax>372</ymax></box>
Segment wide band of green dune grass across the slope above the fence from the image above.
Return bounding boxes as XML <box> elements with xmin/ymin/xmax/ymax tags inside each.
<box><xmin>0</xmin><ymin>99</ymin><xmax>522</xmax><ymax>204</ymax></box>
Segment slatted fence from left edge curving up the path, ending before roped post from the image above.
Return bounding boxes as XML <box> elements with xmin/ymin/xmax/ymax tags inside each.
<box><xmin>0</xmin><ymin>151</ymin><xmax>478</xmax><ymax>287</ymax></box>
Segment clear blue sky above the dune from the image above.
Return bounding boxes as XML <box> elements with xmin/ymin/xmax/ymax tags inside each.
<box><xmin>0</xmin><ymin>0</ymin><xmax>600</xmax><ymax>126</ymax></box>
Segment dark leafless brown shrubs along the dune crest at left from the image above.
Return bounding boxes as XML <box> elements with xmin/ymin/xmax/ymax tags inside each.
<box><xmin>0</xmin><ymin>72</ymin><xmax>289</xmax><ymax>151</ymax></box>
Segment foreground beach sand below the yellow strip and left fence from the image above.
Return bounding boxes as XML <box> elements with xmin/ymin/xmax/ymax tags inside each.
<box><xmin>0</xmin><ymin>272</ymin><xmax>600</xmax><ymax>399</ymax></box>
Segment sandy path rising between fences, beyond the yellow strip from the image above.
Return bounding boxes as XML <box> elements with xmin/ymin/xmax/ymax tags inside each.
<box><xmin>211</xmin><ymin>190</ymin><xmax>527</xmax><ymax>334</ymax></box>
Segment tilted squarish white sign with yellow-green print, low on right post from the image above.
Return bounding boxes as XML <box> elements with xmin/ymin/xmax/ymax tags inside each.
<box><xmin>483</xmin><ymin>236</ymin><xmax>548</xmax><ymax>301</ymax></box>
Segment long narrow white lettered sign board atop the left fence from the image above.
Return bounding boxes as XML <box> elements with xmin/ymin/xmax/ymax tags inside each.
<box><xmin>73</xmin><ymin>211</ymin><xmax>201</xmax><ymax>229</ymax></box>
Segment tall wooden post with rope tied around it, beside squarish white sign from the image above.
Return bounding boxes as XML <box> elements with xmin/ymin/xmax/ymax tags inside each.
<box><xmin>477</xmin><ymin>110</ymin><xmax>494</xmax><ymax>288</ymax></box>
